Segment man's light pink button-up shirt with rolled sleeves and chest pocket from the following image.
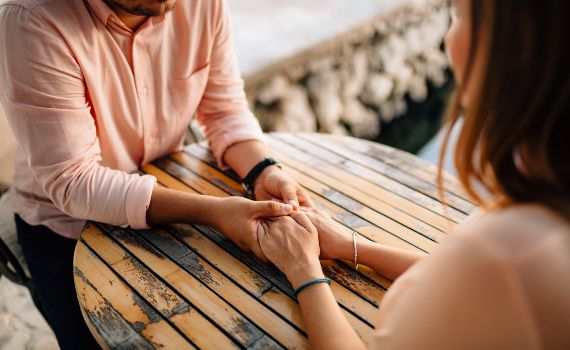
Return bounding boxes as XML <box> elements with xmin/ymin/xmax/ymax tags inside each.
<box><xmin>0</xmin><ymin>0</ymin><xmax>262</xmax><ymax>238</ymax></box>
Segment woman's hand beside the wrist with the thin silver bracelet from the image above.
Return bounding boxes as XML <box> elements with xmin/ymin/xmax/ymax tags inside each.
<box><xmin>300</xmin><ymin>207</ymin><xmax>354</xmax><ymax>260</ymax></box>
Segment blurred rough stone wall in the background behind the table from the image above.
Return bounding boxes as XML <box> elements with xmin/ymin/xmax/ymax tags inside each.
<box><xmin>246</xmin><ymin>0</ymin><xmax>449</xmax><ymax>139</ymax></box>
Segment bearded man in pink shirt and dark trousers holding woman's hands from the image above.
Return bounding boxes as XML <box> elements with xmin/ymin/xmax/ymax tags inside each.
<box><xmin>0</xmin><ymin>0</ymin><xmax>309</xmax><ymax>348</ymax></box>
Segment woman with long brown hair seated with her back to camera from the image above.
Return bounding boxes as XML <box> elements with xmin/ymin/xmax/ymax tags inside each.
<box><xmin>258</xmin><ymin>0</ymin><xmax>570</xmax><ymax>349</ymax></box>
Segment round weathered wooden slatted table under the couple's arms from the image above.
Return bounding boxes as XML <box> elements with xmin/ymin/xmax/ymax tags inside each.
<box><xmin>74</xmin><ymin>134</ymin><xmax>474</xmax><ymax>349</ymax></box>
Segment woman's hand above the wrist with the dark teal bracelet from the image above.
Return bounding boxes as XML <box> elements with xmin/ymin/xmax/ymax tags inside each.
<box><xmin>258</xmin><ymin>213</ymin><xmax>324</xmax><ymax>288</ymax></box>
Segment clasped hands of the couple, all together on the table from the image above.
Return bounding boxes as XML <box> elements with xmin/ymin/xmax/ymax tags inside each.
<box><xmin>209</xmin><ymin>169</ymin><xmax>353</xmax><ymax>286</ymax></box>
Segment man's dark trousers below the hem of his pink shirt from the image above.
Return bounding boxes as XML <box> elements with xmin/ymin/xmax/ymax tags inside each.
<box><xmin>16</xmin><ymin>215</ymin><xmax>100</xmax><ymax>350</ymax></box>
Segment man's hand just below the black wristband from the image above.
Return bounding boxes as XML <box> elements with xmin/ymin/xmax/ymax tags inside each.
<box><xmin>254</xmin><ymin>166</ymin><xmax>313</xmax><ymax>210</ymax></box>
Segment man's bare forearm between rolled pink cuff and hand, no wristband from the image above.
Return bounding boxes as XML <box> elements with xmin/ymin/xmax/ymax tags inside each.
<box><xmin>146</xmin><ymin>186</ymin><xmax>221</xmax><ymax>225</ymax></box>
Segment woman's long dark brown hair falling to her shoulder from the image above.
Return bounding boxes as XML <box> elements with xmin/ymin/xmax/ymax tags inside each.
<box><xmin>438</xmin><ymin>0</ymin><xmax>570</xmax><ymax>218</ymax></box>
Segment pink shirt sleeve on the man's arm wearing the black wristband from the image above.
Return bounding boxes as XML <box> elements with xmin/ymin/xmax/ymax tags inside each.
<box><xmin>197</xmin><ymin>0</ymin><xmax>264</xmax><ymax>168</ymax></box>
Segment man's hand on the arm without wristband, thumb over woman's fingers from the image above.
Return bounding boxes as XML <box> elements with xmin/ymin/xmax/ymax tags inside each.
<box><xmin>207</xmin><ymin>197</ymin><xmax>293</xmax><ymax>261</ymax></box>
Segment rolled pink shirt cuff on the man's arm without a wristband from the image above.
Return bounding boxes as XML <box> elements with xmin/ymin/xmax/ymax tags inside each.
<box><xmin>127</xmin><ymin>175</ymin><xmax>156</xmax><ymax>230</ymax></box>
